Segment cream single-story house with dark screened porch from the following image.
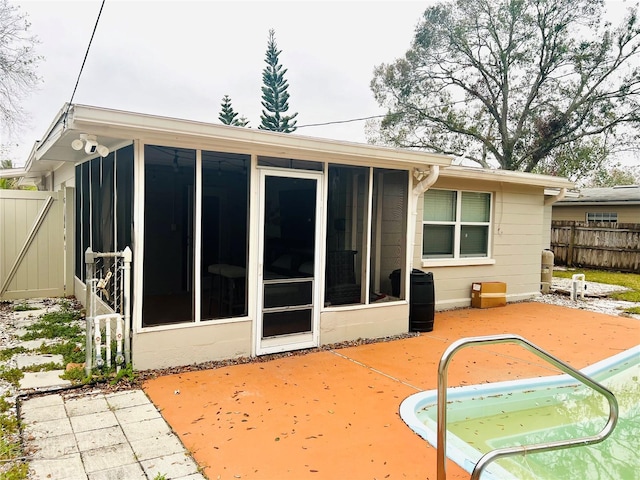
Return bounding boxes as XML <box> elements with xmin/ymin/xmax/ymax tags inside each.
<box><xmin>16</xmin><ymin>105</ymin><xmax>573</xmax><ymax>369</ymax></box>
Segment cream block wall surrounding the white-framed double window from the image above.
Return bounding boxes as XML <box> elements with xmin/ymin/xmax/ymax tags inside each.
<box><xmin>413</xmin><ymin>177</ymin><xmax>549</xmax><ymax>310</ymax></box>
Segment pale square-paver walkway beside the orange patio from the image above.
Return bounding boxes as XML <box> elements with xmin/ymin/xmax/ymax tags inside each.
<box><xmin>21</xmin><ymin>390</ymin><xmax>205</xmax><ymax>480</ymax></box>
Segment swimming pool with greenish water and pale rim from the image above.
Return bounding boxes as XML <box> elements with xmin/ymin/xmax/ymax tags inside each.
<box><xmin>400</xmin><ymin>346</ymin><xmax>640</xmax><ymax>480</ymax></box>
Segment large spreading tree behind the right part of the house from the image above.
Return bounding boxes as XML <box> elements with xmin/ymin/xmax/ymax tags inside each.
<box><xmin>371</xmin><ymin>0</ymin><xmax>640</xmax><ymax>172</ymax></box>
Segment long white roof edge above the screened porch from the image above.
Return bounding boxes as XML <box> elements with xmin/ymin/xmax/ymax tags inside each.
<box><xmin>67</xmin><ymin>105</ymin><xmax>452</xmax><ymax>166</ymax></box>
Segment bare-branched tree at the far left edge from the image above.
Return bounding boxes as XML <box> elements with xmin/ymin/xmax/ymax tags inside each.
<box><xmin>0</xmin><ymin>0</ymin><xmax>41</xmax><ymax>131</ymax></box>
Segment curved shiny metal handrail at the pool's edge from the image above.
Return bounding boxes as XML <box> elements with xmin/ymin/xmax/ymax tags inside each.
<box><xmin>436</xmin><ymin>335</ymin><xmax>618</xmax><ymax>480</ymax></box>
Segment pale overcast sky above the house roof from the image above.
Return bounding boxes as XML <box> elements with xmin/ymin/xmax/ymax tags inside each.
<box><xmin>2</xmin><ymin>0</ymin><xmax>640</xmax><ymax>169</ymax></box>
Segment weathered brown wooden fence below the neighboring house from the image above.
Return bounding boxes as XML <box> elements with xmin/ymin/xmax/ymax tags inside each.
<box><xmin>551</xmin><ymin>220</ymin><xmax>640</xmax><ymax>273</ymax></box>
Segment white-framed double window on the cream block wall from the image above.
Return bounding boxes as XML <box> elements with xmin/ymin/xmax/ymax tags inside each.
<box><xmin>422</xmin><ymin>190</ymin><xmax>491</xmax><ymax>258</ymax></box>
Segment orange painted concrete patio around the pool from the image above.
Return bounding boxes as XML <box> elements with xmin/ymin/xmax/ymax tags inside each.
<box><xmin>144</xmin><ymin>302</ymin><xmax>640</xmax><ymax>480</ymax></box>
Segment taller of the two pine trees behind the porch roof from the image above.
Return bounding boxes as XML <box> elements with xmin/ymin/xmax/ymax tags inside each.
<box><xmin>258</xmin><ymin>29</ymin><xmax>298</xmax><ymax>133</ymax></box>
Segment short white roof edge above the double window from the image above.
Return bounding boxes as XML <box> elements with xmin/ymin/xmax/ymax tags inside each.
<box><xmin>440</xmin><ymin>165</ymin><xmax>575</xmax><ymax>189</ymax></box>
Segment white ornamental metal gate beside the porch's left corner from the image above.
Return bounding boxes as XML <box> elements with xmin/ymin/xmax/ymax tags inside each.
<box><xmin>84</xmin><ymin>247</ymin><xmax>132</xmax><ymax>375</ymax></box>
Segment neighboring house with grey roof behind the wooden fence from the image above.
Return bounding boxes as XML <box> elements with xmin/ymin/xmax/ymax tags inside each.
<box><xmin>552</xmin><ymin>185</ymin><xmax>640</xmax><ymax>223</ymax></box>
